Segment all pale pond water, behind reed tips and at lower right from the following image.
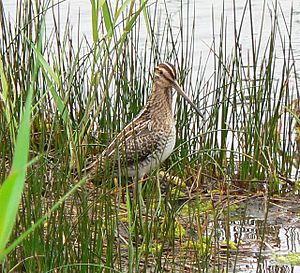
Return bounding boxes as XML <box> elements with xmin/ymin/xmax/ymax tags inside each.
<box><xmin>4</xmin><ymin>0</ymin><xmax>300</xmax><ymax>273</ymax></box>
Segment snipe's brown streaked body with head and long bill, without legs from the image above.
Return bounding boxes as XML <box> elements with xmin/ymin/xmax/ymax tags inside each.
<box><xmin>88</xmin><ymin>63</ymin><xmax>201</xmax><ymax>179</ymax></box>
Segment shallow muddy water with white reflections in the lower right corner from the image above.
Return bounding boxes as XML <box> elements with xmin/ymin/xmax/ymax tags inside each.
<box><xmin>219</xmin><ymin>198</ymin><xmax>300</xmax><ymax>273</ymax></box>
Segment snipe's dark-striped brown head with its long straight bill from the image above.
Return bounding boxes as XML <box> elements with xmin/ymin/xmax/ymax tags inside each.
<box><xmin>153</xmin><ymin>63</ymin><xmax>202</xmax><ymax>116</ymax></box>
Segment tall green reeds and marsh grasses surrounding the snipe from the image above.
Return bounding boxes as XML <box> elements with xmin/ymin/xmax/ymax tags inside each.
<box><xmin>0</xmin><ymin>0</ymin><xmax>300</xmax><ymax>272</ymax></box>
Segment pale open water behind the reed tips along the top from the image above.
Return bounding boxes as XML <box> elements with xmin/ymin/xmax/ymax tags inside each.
<box><xmin>4</xmin><ymin>0</ymin><xmax>300</xmax><ymax>74</ymax></box>
